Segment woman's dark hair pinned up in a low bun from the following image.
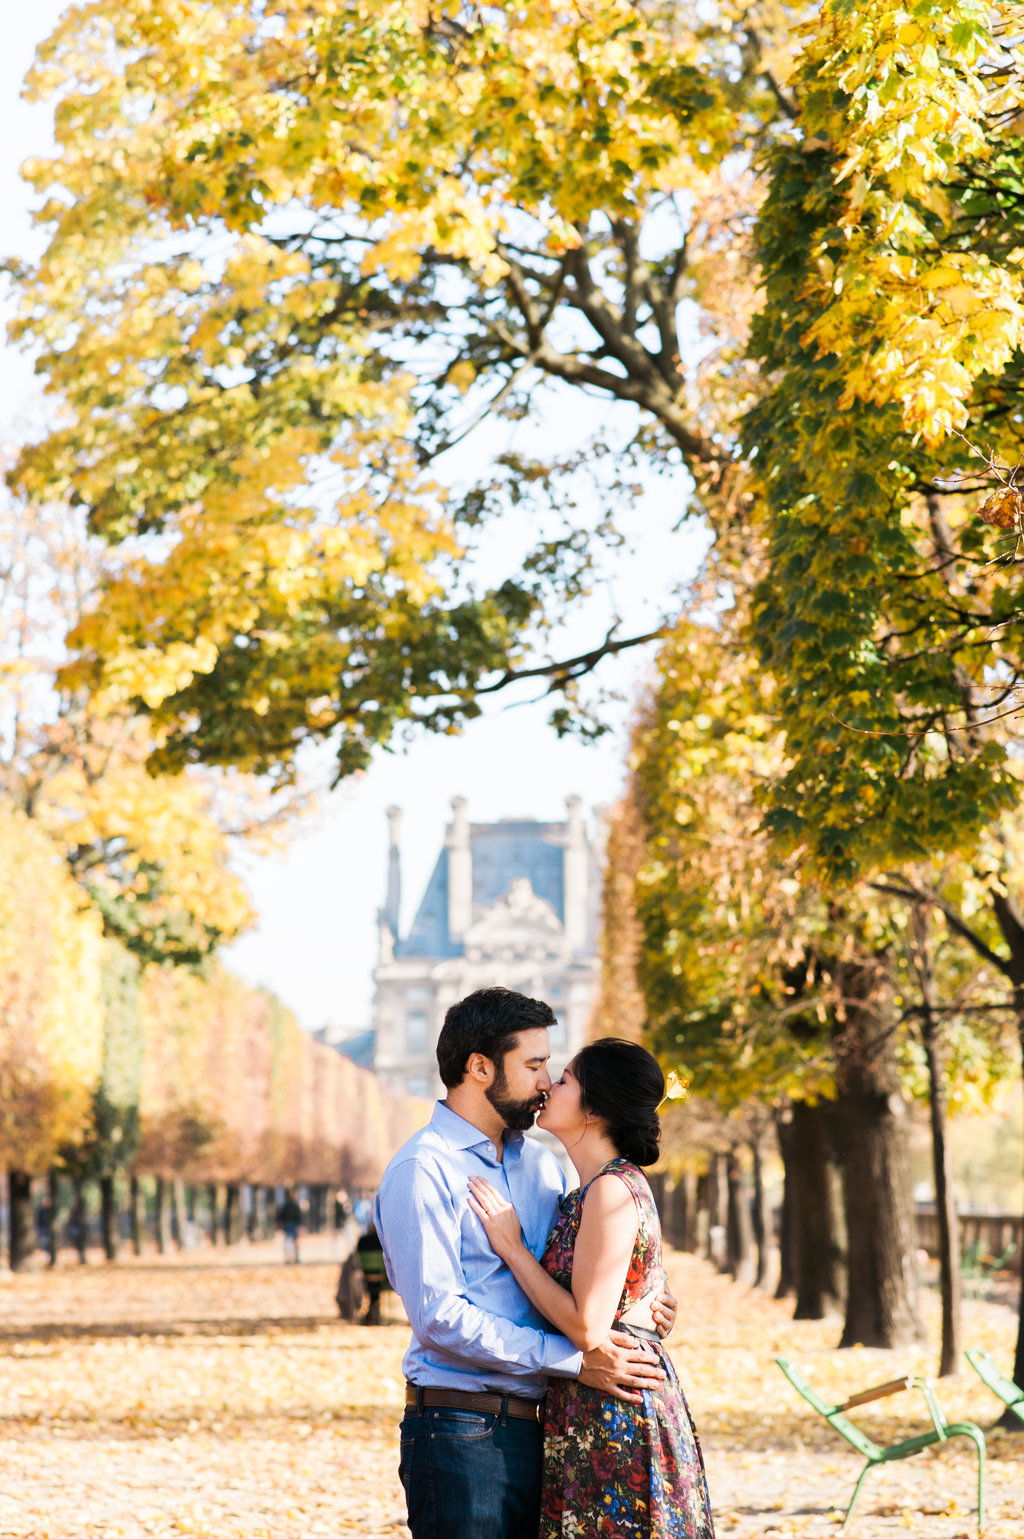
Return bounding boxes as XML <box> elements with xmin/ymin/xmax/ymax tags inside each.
<box><xmin>570</xmin><ymin>1037</ymin><xmax>665</xmax><ymax>1165</ymax></box>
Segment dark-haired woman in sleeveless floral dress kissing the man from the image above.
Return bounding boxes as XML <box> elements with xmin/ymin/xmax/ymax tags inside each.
<box><xmin>470</xmin><ymin>1037</ymin><xmax>714</xmax><ymax>1539</ymax></box>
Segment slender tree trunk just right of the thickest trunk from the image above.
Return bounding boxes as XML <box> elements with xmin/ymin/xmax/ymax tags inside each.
<box><xmin>910</xmin><ymin>903</ymin><xmax>962</xmax><ymax>1377</ymax></box>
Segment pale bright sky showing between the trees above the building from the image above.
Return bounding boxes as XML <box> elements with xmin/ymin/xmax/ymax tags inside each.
<box><xmin>0</xmin><ymin>0</ymin><xmax>704</xmax><ymax>1031</ymax></box>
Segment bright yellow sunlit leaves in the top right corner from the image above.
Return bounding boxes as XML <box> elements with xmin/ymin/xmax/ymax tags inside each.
<box><xmin>798</xmin><ymin>0</ymin><xmax>1024</xmax><ymax>443</ymax></box>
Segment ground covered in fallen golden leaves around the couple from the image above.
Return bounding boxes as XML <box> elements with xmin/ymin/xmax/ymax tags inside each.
<box><xmin>0</xmin><ymin>1242</ymin><xmax>1024</xmax><ymax>1539</ymax></box>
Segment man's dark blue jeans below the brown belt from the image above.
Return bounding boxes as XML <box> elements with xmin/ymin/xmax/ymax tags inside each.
<box><xmin>399</xmin><ymin>1407</ymin><xmax>544</xmax><ymax>1539</ymax></box>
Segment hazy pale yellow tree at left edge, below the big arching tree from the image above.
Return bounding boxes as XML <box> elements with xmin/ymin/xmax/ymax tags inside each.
<box><xmin>0</xmin><ymin>464</ymin><xmax>287</xmax><ymax>965</ymax></box>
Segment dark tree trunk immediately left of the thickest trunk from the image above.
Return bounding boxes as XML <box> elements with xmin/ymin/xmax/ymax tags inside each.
<box><xmin>787</xmin><ymin>1100</ymin><xmax>842</xmax><ymax>1320</ymax></box>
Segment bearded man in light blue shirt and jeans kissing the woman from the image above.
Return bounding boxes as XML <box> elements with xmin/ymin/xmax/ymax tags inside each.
<box><xmin>376</xmin><ymin>988</ymin><xmax>674</xmax><ymax>1539</ymax></box>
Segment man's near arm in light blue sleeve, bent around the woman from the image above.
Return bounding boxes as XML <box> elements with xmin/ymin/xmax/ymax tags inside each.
<box><xmin>376</xmin><ymin>1160</ymin><xmax>582</xmax><ymax>1379</ymax></box>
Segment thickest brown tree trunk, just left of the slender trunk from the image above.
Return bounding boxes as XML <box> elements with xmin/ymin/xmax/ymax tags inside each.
<box><xmin>835</xmin><ymin>956</ymin><xmax>924</xmax><ymax>1347</ymax></box>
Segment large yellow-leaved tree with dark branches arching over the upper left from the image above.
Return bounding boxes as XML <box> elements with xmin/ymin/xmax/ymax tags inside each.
<box><xmin>5</xmin><ymin>0</ymin><xmax>793</xmax><ymax>776</ymax></box>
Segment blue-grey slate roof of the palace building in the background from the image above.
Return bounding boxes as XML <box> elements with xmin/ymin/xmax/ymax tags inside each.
<box><xmin>394</xmin><ymin>819</ymin><xmax>565</xmax><ymax>959</ymax></box>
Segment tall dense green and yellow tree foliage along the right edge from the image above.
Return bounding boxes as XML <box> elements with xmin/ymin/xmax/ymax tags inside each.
<box><xmin>747</xmin><ymin>3</ymin><xmax>1024</xmax><ymax>1374</ymax></box>
